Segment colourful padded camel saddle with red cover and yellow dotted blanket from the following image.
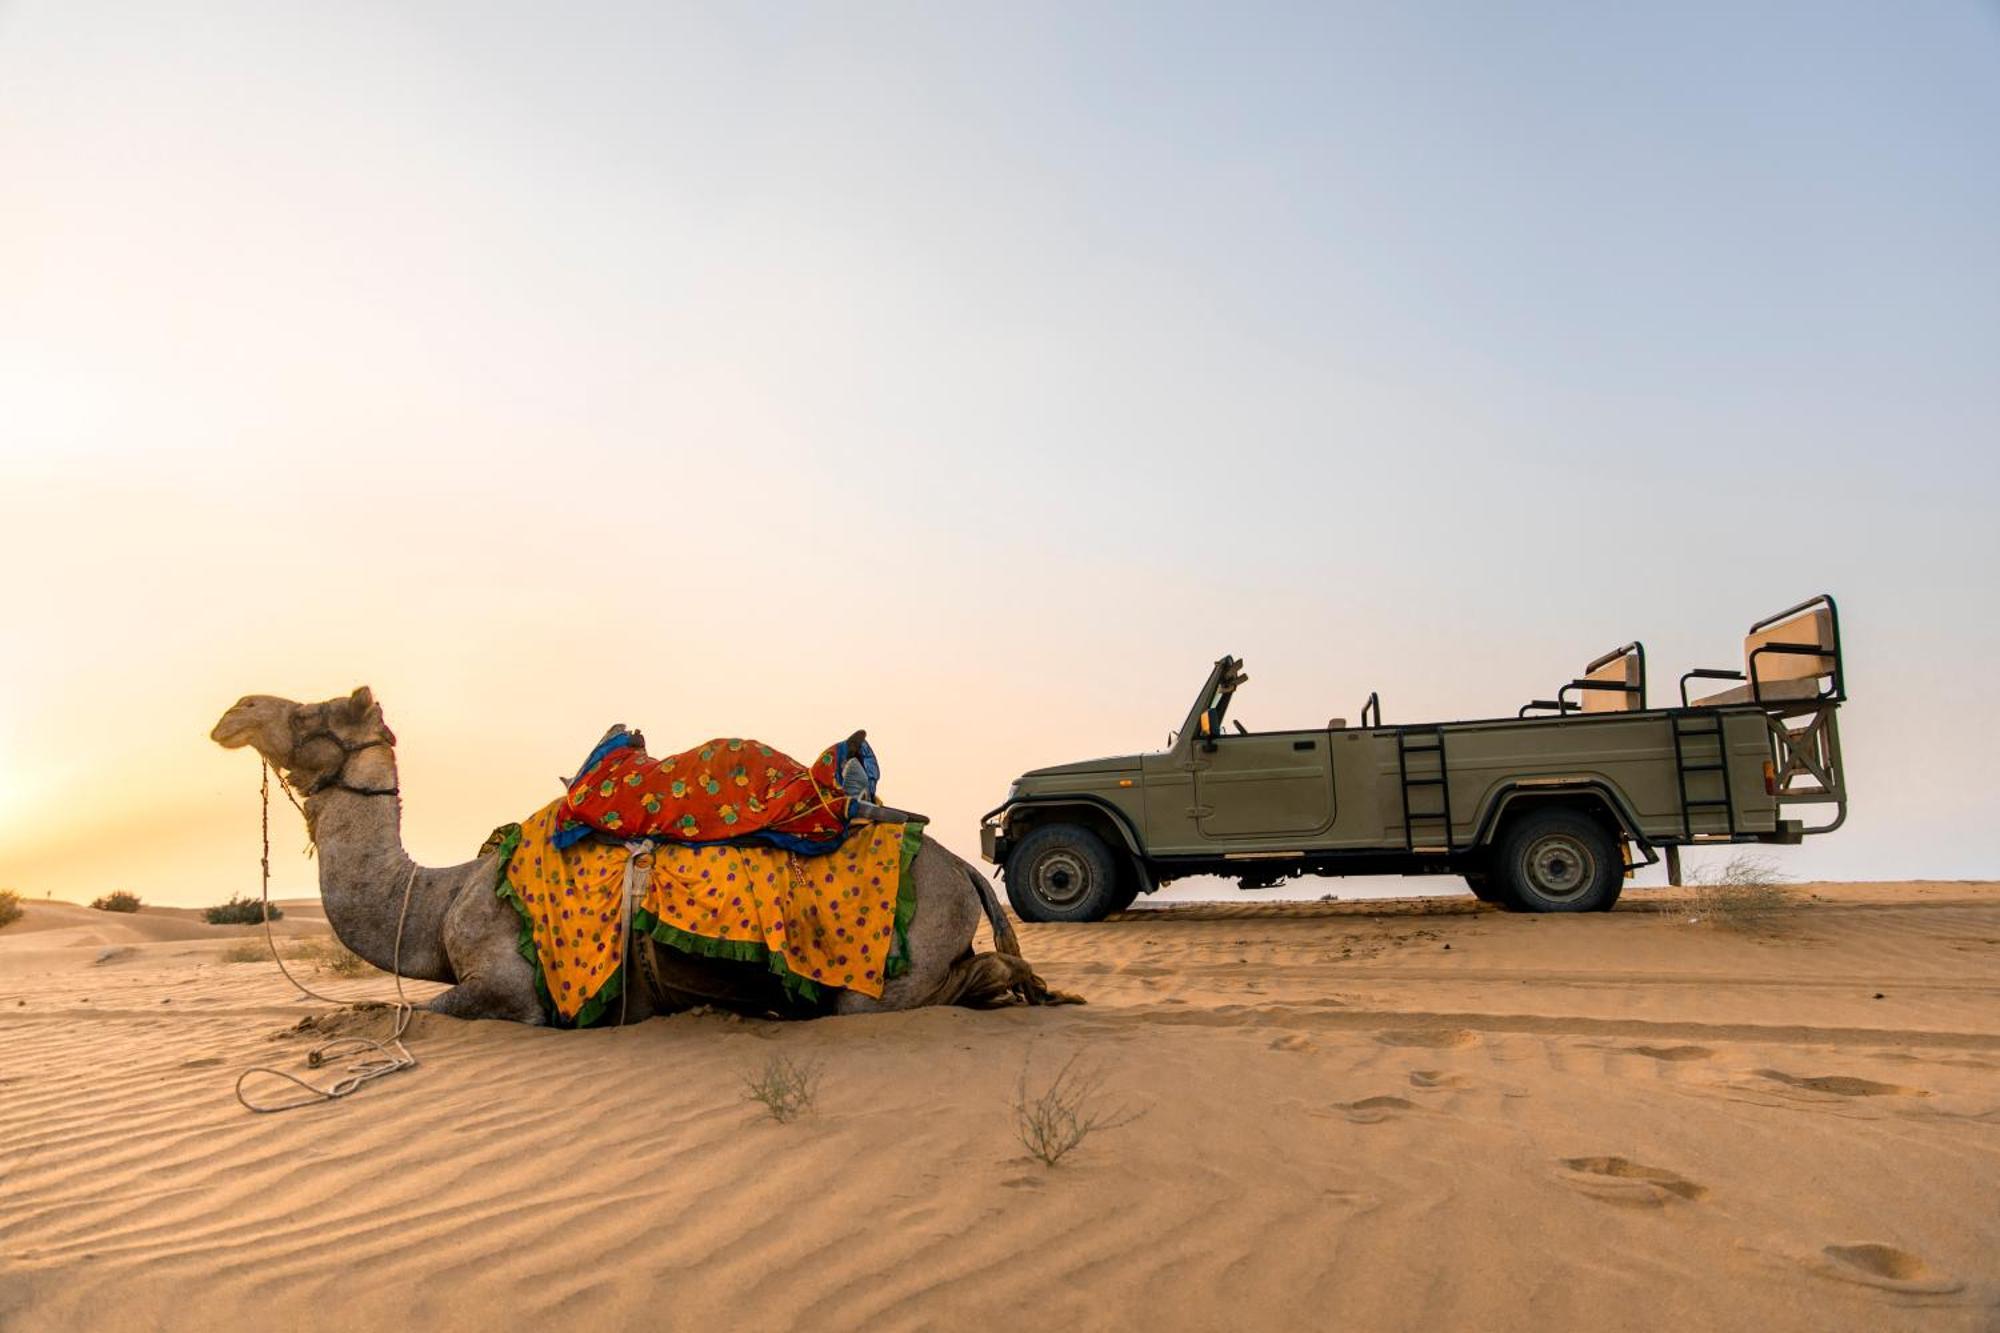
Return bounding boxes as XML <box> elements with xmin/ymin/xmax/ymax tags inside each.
<box><xmin>488</xmin><ymin>725</ymin><xmax>926</xmax><ymax>1027</ymax></box>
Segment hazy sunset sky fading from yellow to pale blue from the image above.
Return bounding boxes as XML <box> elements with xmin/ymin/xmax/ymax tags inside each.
<box><xmin>0</xmin><ymin>0</ymin><xmax>2000</xmax><ymax>905</ymax></box>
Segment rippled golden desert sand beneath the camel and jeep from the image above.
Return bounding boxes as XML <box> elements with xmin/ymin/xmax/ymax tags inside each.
<box><xmin>0</xmin><ymin>885</ymin><xmax>2000</xmax><ymax>1331</ymax></box>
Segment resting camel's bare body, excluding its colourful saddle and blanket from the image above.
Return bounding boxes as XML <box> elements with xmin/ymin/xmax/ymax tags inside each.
<box><xmin>210</xmin><ymin>687</ymin><xmax>1074</xmax><ymax>1025</ymax></box>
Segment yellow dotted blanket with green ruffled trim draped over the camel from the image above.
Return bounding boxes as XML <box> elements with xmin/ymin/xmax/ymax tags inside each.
<box><xmin>482</xmin><ymin>801</ymin><xmax>924</xmax><ymax>1027</ymax></box>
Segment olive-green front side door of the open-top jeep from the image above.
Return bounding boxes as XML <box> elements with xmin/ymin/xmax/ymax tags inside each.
<box><xmin>1192</xmin><ymin>731</ymin><xmax>1334</xmax><ymax>839</ymax></box>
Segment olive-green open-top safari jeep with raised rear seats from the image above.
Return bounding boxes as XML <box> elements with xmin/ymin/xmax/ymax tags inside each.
<box><xmin>980</xmin><ymin>596</ymin><xmax>1846</xmax><ymax>921</ymax></box>
